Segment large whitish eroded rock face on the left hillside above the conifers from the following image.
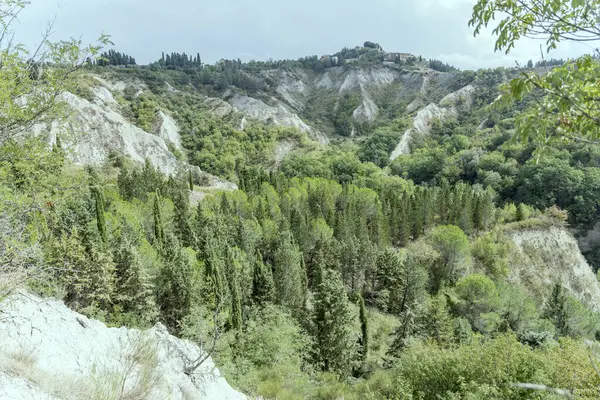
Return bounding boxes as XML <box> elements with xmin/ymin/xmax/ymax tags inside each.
<box><xmin>31</xmin><ymin>81</ymin><xmax>237</xmax><ymax>189</ymax></box>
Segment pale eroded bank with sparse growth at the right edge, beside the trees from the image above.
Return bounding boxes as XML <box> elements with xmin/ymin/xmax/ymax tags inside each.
<box><xmin>508</xmin><ymin>227</ymin><xmax>600</xmax><ymax>311</ymax></box>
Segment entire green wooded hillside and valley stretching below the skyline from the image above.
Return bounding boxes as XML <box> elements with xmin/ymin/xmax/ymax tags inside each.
<box><xmin>0</xmin><ymin>0</ymin><xmax>600</xmax><ymax>400</ymax></box>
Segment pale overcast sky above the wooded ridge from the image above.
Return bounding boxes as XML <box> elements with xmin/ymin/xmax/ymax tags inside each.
<box><xmin>12</xmin><ymin>0</ymin><xmax>591</xmax><ymax>69</ymax></box>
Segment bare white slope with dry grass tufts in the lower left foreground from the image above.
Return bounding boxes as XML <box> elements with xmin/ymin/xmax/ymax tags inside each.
<box><xmin>0</xmin><ymin>292</ymin><xmax>246</xmax><ymax>400</ymax></box>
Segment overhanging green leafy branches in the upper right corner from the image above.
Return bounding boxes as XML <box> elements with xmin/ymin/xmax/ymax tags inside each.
<box><xmin>469</xmin><ymin>0</ymin><xmax>600</xmax><ymax>148</ymax></box>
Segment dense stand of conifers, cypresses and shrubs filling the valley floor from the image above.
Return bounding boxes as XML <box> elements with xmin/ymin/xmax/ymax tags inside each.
<box><xmin>1</xmin><ymin>141</ymin><xmax>600</xmax><ymax>398</ymax></box>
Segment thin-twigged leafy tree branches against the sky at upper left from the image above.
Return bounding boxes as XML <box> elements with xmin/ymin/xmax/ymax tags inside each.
<box><xmin>0</xmin><ymin>0</ymin><xmax>110</xmax><ymax>144</ymax></box>
